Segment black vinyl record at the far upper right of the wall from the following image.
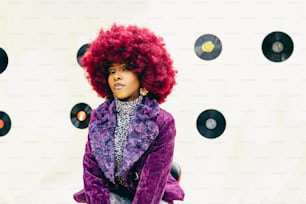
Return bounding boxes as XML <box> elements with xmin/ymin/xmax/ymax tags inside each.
<box><xmin>262</xmin><ymin>32</ymin><xmax>293</xmax><ymax>62</ymax></box>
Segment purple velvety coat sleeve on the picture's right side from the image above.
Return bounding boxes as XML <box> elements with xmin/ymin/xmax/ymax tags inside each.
<box><xmin>132</xmin><ymin>110</ymin><xmax>176</xmax><ymax>204</ymax></box>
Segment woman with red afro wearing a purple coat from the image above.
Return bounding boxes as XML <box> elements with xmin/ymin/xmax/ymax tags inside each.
<box><xmin>74</xmin><ymin>24</ymin><xmax>184</xmax><ymax>204</ymax></box>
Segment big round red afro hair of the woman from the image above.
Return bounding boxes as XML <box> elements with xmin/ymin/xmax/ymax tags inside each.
<box><xmin>81</xmin><ymin>24</ymin><xmax>176</xmax><ymax>103</ymax></box>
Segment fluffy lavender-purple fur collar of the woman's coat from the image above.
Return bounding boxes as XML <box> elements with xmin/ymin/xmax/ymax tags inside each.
<box><xmin>89</xmin><ymin>97</ymin><xmax>160</xmax><ymax>183</ymax></box>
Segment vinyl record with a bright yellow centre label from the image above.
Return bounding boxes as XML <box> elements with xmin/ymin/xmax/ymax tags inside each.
<box><xmin>194</xmin><ymin>34</ymin><xmax>222</xmax><ymax>60</ymax></box>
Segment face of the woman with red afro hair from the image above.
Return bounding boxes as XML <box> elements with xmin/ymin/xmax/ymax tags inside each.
<box><xmin>108</xmin><ymin>63</ymin><xmax>140</xmax><ymax>101</ymax></box>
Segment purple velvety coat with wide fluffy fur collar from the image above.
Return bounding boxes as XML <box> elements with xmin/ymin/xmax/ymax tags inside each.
<box><xmin>74</xmin><ymin>97</ymin><xmax>184</xmax><ymax>204</ymax></box>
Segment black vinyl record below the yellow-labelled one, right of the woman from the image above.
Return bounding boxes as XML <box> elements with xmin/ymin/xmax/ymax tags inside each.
<box><xmin>197</xmin><ymin>109</ymin><xmax>226</xmax><ymax>138</ymax></box>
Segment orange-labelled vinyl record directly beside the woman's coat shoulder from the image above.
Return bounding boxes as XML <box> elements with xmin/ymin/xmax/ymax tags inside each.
<box><xmin>70</xmin><ymin>103</ymin><xmax>92</xmax><ymax>129</ymax></box>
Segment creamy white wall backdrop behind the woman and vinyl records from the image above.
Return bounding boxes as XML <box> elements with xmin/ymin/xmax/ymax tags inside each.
<box><xmin>0</xmin><ymin>0</ymin><xmax>306</xmax><ymax>204</ymax></box>
